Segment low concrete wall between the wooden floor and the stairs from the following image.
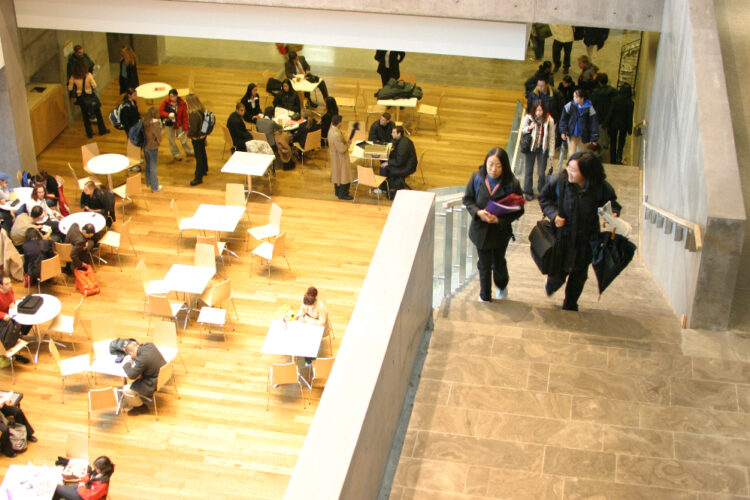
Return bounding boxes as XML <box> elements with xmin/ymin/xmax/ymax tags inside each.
<box><xmin>284</xmin><ymin>191</ymin><xmax>435</xmax><ymax>500</ymax></box>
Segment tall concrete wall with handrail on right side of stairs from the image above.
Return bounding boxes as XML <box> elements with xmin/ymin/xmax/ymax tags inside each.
<box><xmin>641</xmin><ymin>0</ymin><xmax>745</xmax><ymax>329</ymax></box>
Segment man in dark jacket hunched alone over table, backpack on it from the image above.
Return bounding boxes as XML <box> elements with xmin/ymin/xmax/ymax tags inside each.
<box><xmin>122</xmin><ymin>342</ymin><xmax>167</xmax><ymax>416</ymax></box>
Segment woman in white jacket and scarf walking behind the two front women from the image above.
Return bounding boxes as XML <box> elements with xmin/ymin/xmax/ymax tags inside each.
<box><xmin>521</xmin><ymin>101</ymin><xmax>555</xmax><ymax>201</ymax></box>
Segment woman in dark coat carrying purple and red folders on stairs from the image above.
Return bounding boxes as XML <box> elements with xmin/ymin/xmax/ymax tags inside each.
<box><xmin>463</xmin><ymin>147</ymin><xmax>523</xmax><ymax>302</ymax></box>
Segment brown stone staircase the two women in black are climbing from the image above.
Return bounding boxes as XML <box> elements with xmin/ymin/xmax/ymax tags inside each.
<box><xmin>391</xmin><ymin>166</ymin><xmax>750</xmax><ymax>500</ymax></box>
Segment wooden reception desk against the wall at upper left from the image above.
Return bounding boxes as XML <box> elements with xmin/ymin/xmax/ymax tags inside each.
<box><xmin>26</xmin><ymin>83</ymin><xmax>68</xmax><ymax>156</ymax></box>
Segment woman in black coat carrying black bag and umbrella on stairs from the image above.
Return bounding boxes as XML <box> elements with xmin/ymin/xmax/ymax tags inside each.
<box><xmin>539</xmin><ymin>151</ymin><xmax>622</xmax><ymax>311</ymax></box>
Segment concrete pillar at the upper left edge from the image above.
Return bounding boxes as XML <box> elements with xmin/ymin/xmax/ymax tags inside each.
<box><xmin>0</xmin><ymin>0</ymin><xmax>37</xmax><ymax>180</ymax></box>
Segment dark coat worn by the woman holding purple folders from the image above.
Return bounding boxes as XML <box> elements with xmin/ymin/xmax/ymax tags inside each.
<box><xmin>463</xmin><ymin>172</ymin><xmax>524</xmax><ymax>250</ymax></box>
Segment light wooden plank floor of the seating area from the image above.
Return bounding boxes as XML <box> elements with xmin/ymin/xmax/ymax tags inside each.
<box><xmin>0</xmin><ymin>66</ymin><xmax>518</xmax><ymax>499</ymax></box>
